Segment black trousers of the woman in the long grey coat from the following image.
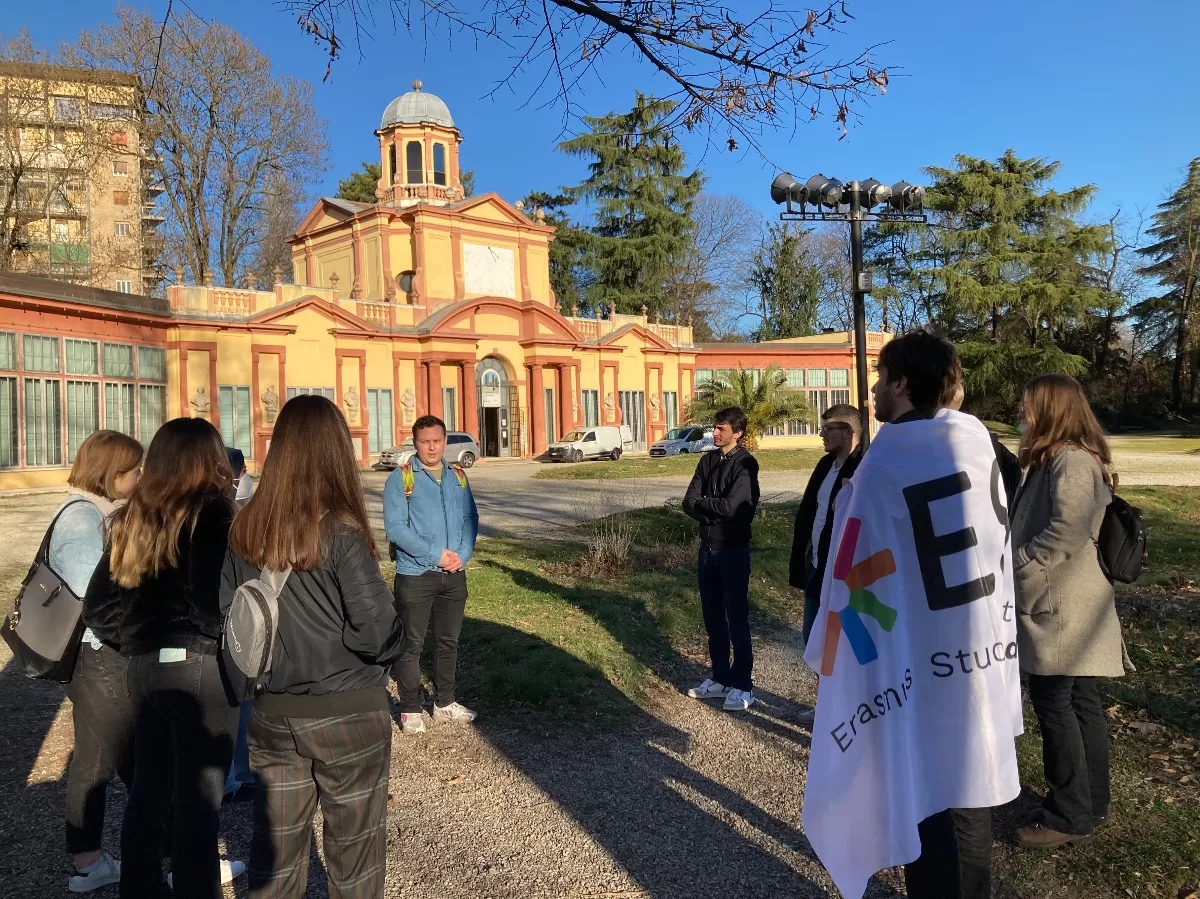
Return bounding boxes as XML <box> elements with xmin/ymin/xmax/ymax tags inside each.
<box><xmin>1030</xmin><ymin>675</ymin><xmax>1109</xmax><ymax>834</ymax></box>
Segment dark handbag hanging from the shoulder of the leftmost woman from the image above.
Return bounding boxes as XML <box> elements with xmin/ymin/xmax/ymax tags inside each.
<box><xmin>0</xmin><ymin>499</ymin><xmax>86</xmax><ymax>684</ymax></box>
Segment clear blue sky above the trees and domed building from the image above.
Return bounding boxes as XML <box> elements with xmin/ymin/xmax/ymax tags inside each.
<box><xmin>14</xmin><ymin>0</ymin><xmax>1200</xmax><ymax>228</ymax></box>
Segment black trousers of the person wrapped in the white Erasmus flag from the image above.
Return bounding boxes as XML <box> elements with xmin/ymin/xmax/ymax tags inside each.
<box><xmin>904</xmin><ymin>809</ymin><xmax>991</xmax><ymax>899</ymax></box>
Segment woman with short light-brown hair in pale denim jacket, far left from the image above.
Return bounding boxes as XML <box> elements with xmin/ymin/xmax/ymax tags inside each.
<box><xmin>48</xmin><ymin>431</ymin><xmax>143</xmax><ymax>893</ymax></box>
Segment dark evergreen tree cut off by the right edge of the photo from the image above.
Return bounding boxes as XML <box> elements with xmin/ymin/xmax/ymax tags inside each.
<box><xmin>1134</xmin><ymin>157</ymin><xmax>1200</xmax><ymax>412</ymax></box>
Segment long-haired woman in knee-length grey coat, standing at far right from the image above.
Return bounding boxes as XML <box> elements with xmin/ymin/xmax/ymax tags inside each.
<box><xmin>1012</xmin><ymin>374</ymin><xmax>1124</xmax><ymax>847</ymax></box>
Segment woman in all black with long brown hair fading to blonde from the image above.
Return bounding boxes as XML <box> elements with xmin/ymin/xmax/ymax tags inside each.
<box><xmin>84</xmin><ymin>418</ymin><xmax>238</xmax><ymax>899</ymax></box>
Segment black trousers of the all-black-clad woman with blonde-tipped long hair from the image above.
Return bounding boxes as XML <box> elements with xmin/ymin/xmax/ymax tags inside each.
<box><xmin>121</xmin><ymin>653</ymin><xmax>238</xmax><ymax>899</ymax></box>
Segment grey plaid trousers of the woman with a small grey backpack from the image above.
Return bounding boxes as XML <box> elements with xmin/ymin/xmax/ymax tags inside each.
<box><xmin>247</xmin><ymin>708</ymin><xmax>391</xmax><ymax>899</ymax></box>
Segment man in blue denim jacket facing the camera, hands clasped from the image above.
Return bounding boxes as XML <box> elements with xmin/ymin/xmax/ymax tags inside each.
<box><xmin>383</xmin><ymin>415</ymin><xmax>479</xmax><ymax>735</ymax></box>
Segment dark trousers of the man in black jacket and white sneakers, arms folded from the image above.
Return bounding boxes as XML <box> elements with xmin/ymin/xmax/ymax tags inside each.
<box><xmin>696</xmin><ymin>546</ymin><xmax>754</xmax><ymax>690</ymax></box>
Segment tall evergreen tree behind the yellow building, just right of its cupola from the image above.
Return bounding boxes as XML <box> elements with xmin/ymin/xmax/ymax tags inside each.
<box><xmin>559</xmin><ymin>92</ymin><xmax>704</xmax><ymax>316</ymax></box>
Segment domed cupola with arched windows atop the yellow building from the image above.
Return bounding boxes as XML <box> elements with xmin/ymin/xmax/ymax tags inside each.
<box><xmin>376</xmin><ymin>80</ymin><xmax>463</xmax><ymax>206</ymax></box>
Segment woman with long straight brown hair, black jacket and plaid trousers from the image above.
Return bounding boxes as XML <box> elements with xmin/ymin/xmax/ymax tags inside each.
<box><xmin>221</xmin><ymin>396</ymin><xmax>403</xmax><ymax>899</ymax></box>
